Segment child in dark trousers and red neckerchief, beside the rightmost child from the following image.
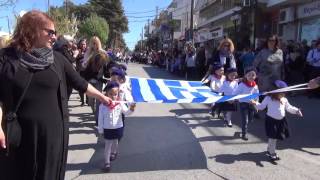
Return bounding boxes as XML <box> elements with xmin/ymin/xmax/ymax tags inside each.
<box><xmin>234</xmin><ymin>67</ymin><xmax>259</xmax><ymax>141</ymax></box>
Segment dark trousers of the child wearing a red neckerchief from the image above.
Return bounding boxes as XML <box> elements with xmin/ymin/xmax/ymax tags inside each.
<box><xmin>240</xmin><ymin>103</ymin><xmax>255</xmax><ymax>135</ymax></box>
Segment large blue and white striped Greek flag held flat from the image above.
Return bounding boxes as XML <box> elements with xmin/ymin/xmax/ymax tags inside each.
<box><xmin>130</xmin><ymin>77</ymin><xmax>259</xmax><ymax>103</ymax></box>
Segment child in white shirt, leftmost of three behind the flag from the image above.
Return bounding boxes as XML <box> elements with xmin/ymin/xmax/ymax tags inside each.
<box><xmin>203</xmin><ymin>63</ymin><xmax>226</xmax><ymax>118</ymax></box>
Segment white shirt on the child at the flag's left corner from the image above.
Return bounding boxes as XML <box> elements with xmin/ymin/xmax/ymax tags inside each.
<box><xmin>98</xmin><ymin>103</ymin><xmax>132</xmax><ymax>133</ymax></box>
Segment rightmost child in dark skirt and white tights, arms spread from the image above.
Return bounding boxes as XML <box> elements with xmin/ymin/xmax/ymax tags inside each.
<box><xmin>252</xmin><ymin>80</ymin><xmax>302</xmax><ymax>161</ymax></box>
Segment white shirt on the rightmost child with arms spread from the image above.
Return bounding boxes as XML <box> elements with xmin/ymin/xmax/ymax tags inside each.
<box><xmin>256</xmin><ymin>96</ymin><xmax>299</xmax><ymax>120</ymax></box>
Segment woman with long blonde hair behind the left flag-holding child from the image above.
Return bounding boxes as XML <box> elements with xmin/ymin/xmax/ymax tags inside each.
<box><xmin>84</xmin><ymin>36</ymin><xmax>110</xmax><ymax>124</ymax></box>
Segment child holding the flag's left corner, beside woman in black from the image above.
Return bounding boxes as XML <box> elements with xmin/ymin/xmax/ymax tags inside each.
<box><xmin>98</xmin><ymin>81</ymin><xmax>135</xmax><ymax>172</ymax></box>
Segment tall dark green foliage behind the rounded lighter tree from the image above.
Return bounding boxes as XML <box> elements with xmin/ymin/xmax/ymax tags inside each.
<box><xmin>50</xmin><ymin>0</ymin><xmax>129</xmax><ymax>48</ymax></box>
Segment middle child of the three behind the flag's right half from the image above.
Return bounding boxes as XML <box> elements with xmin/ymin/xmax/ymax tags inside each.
<box><xmin>219</xmin><ymin>68</ymin><xmax>239</xmax><ymax>127</ymax></box>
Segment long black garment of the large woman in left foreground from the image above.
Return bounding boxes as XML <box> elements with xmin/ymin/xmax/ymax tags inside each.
<box><xmin>0</xmin><ymin>48</ymin><xmax>88</xmax><ymax>180</ymax></box>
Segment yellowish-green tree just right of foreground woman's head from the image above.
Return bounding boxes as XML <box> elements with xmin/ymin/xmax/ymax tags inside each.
<box><xmin>50</xmin><ymin>7</ymin><xmax>78</xmax><ymax>36</ymax></box>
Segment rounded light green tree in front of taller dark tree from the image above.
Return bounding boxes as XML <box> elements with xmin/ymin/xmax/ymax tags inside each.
<box><xmin>78</xmin><ymin>14</ymin><xmax>109</xmax><ymax>44</ymax></box>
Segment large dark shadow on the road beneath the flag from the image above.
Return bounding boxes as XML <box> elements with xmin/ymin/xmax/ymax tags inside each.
<box><xmin>67</xmin><ymin>116</ymin><xmax>207</xmax><ymax>175</ymax></box>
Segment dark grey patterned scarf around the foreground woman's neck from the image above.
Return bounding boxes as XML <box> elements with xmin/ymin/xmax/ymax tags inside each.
<box><xmin>20</xmin><ymin>47</ymin><xmax>54</xmax><ymax>70</ymax></box>
